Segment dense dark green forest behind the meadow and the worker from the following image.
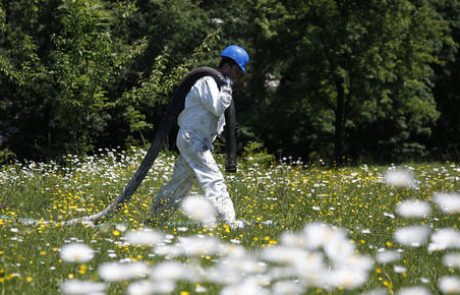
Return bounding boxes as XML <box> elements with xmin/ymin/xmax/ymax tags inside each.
<box><xmin>0</xmin><ymin>0</ymin><xmax>460</xmax><ymax>165</ymax></box>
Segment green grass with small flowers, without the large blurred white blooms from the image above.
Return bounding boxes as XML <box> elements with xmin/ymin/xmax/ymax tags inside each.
<box><xmin>0</xmin><ymin>151</ymin><xmax>460</xmax><ymax>294</ymax></box>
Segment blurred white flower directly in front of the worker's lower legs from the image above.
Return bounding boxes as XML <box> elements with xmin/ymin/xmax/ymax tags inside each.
<box><xmin>182</xmin><ymin>196</ymin><xmax>216</xmax><ymax>225</ymax></box>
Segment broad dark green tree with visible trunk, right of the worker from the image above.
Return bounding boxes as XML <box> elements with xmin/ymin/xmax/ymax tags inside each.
<box><xmin>244</xmin><ymin>0</ymin><xmax>449</xmax><ymax>164</ymax></box>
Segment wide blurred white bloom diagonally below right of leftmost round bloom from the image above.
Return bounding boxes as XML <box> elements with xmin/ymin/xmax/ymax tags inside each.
<box><xmin>98</xmin><ymin>262</ymin><xmax>150</xmax><ymax>282</ymax></box>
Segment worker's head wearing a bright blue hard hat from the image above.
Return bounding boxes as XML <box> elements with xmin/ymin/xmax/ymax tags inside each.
<box><xmin>219</xmin><ymin>45</ymin><xmax>249</xmax><ymax>79</ymax></box>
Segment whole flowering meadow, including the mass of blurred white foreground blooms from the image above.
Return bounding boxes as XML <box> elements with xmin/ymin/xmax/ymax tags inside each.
<box><xmin>0</xmin><ymin>150</ymin><xmax>460</xmax><ymax>295</ymax></box>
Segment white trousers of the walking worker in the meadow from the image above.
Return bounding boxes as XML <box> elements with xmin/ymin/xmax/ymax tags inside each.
<box><xmin>151</xmin><ymin>128</ymin><xmax>235</xmax><ymax>224</ymax></box>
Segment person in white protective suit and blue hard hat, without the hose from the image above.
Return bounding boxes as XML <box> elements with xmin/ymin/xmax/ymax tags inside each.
<box><xmin>151</xmin><ymin>45</ymin><xmax>249</xmax><ymax>227</ymax></box>
